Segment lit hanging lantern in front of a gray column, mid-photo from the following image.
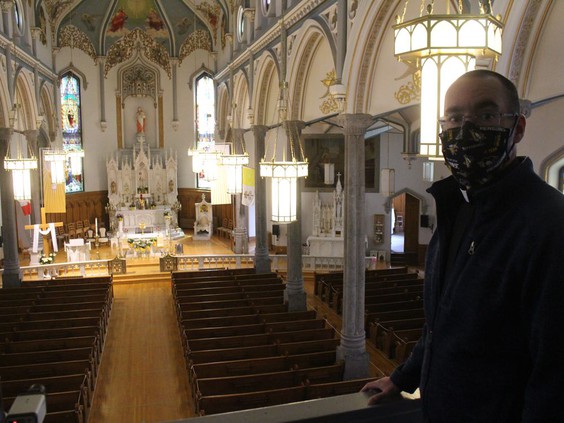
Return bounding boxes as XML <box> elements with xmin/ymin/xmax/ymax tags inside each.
<box><xmin>260</xmin><ymin>100</ymin><xmax>308</xmax><ymax>223</ymax></box>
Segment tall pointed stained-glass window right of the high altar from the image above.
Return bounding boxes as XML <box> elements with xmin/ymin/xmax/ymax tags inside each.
<box><xmin>194</xmin><ymin>73</ymin><xmax>215</xmax><ymax>188</ymax></box>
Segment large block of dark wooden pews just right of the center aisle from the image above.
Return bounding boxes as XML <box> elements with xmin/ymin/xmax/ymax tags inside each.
<box><xmin>172</xmin><ymin>269</ymin><xmax>384</xmax><ymax>415</ymax></box>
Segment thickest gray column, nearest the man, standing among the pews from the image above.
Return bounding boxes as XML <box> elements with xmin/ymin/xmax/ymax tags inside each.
<box><xmin>337</xmin><ymin>114</ymin><xmax>373</xmax><ymax>379</ymax></box>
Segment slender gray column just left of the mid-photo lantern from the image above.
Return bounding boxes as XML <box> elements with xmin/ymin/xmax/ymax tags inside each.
<box><xmin>252</xmin><ymin>125</ymin><xmax>271</xmax><ymax>273</ymax></box>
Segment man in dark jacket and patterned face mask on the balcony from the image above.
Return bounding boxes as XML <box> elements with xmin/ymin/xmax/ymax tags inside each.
<box><xmin>363</xmin><ymin>70</ymin><xmax>564</xmax><ymax>423</ymax></box>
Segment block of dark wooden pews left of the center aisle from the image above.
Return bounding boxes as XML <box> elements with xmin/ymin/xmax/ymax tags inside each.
<box><xmin>0</xmin><ymin>276</ymin><xmax>113</xmax><ymax>423</ymax></box>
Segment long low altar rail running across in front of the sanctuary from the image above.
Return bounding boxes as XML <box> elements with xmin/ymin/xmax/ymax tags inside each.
<box><xmin>0</xmin><ymin>254</ymin><xmax>382</xmax><ymax>280</ymax></box>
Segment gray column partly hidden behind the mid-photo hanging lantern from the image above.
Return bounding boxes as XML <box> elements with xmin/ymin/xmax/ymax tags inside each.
<box><xmin>284</xmin><ymin>120</ymin><xmax>307</xmax><ymax>311</ymax></box>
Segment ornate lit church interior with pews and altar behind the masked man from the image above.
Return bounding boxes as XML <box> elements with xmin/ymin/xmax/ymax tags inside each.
<box><xmin>0</xmin><ymin>0</ymin><xmax>564</xmax><ymax>423</ymax></box>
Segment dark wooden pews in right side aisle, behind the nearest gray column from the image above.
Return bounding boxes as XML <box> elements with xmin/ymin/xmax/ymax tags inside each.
<box><xmin>314</xmin><ymin>266</ymin><xmax>424</xmax><ymax>363</ymax></box>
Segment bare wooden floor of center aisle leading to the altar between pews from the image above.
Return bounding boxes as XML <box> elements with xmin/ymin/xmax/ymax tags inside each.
<box><xmin>88</xmin><ymin>278</ymin><xmax>194</xmax><ymax>423</ymax></box>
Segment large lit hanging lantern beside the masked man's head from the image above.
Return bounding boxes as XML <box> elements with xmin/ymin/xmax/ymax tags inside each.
<box><xmin>394</xmin><ymin>0</ymin><xmax>503</xmax><ymax>160</ymax></box>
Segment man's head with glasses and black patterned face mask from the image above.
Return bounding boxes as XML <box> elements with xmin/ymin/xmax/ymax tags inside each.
<box><xmin>441</xmin><ymin>70</ymin><xmax>526</xmax><ymax>188</ymax></box>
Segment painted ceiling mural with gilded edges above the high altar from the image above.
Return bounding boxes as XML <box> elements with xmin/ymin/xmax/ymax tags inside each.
<box><xmin>36</xmin><ymin>0</ymin><xmax>227</xmax><ymax>76</ymax></box>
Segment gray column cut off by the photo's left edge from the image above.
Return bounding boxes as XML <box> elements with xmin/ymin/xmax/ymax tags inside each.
<box><xmin>0</xmin><ymin>128</ymin><xmax>21</xmax><ymax>288</ymax></box>
